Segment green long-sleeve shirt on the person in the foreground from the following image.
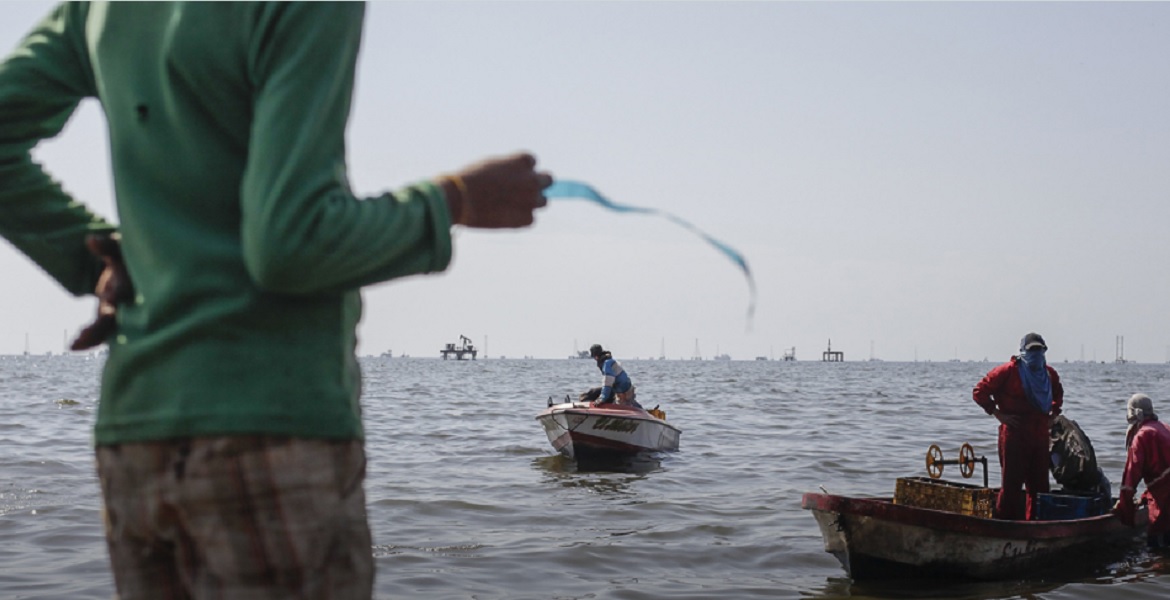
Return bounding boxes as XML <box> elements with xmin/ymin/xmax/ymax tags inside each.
<box><xmin>0</xmin><ymin>2</ymin><xmax>450</xmax><ymax>444</ymax></box>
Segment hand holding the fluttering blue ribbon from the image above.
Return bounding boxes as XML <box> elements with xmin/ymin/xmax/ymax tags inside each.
<box><xmin>439</xmin><ymin>152</ymin><xmax>552</xmax><ymax>229</ymax></box>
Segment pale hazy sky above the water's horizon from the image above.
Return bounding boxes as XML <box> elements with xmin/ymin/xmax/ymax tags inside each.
<box><xmin>0</xmin><ymin>1</ymin><xmax>1170</xmax><ymax>363</ymax></box>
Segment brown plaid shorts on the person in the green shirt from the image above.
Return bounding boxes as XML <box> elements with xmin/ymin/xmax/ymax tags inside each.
<box><xmin>97</xmin><ymin>436</ymin><xmax>373</xmax><ymax>600</ymax></box>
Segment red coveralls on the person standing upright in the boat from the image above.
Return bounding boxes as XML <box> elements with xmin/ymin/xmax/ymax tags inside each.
<box><xmin>971</xmin><ymin>357</ymin><xmax>1065</xmax><ymax>520</ymax></box>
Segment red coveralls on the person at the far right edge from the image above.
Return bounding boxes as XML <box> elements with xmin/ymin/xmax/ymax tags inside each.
<box><xmin>1119</xmin><ymin>420</ymin><xmax>1170</xmax><ymax>545</ymax></box>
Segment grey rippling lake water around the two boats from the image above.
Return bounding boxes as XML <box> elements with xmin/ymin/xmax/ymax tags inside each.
<box><xmin>0</xmin><ymin>357</ymin><xmax>1170</xmax><ymax>600</ymax></box>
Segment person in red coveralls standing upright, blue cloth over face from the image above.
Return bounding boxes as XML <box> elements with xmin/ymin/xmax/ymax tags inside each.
<box><xmin>972</xmin><ymin>333</ymin><xmax>1065</xmax><ymax>520</ymax></box>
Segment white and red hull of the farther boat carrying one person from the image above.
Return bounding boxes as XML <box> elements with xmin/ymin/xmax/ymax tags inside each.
<box><xmin>536</xmin><ymin>402</ymin><xmax>681</xmax><ymax>458</ymax></box>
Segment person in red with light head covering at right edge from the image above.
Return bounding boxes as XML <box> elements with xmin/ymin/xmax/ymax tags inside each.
<box><xmin>1114</xmin><ymin>394</ymin><xmax>1170</xmax><ymax>547</ymax></box>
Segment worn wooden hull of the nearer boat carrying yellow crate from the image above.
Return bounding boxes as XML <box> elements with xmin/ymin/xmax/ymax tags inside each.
<box><xmin>800</xmin><ymin>494</ymin><xmax>1145</xmax><ymax>580</ymax></box>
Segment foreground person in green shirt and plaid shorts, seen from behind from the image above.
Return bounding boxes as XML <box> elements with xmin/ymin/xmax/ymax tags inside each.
<box><xmin>0</xmin><ymin>2</ymin><xmax>551</xmax><ymax>599</ymax></box>
